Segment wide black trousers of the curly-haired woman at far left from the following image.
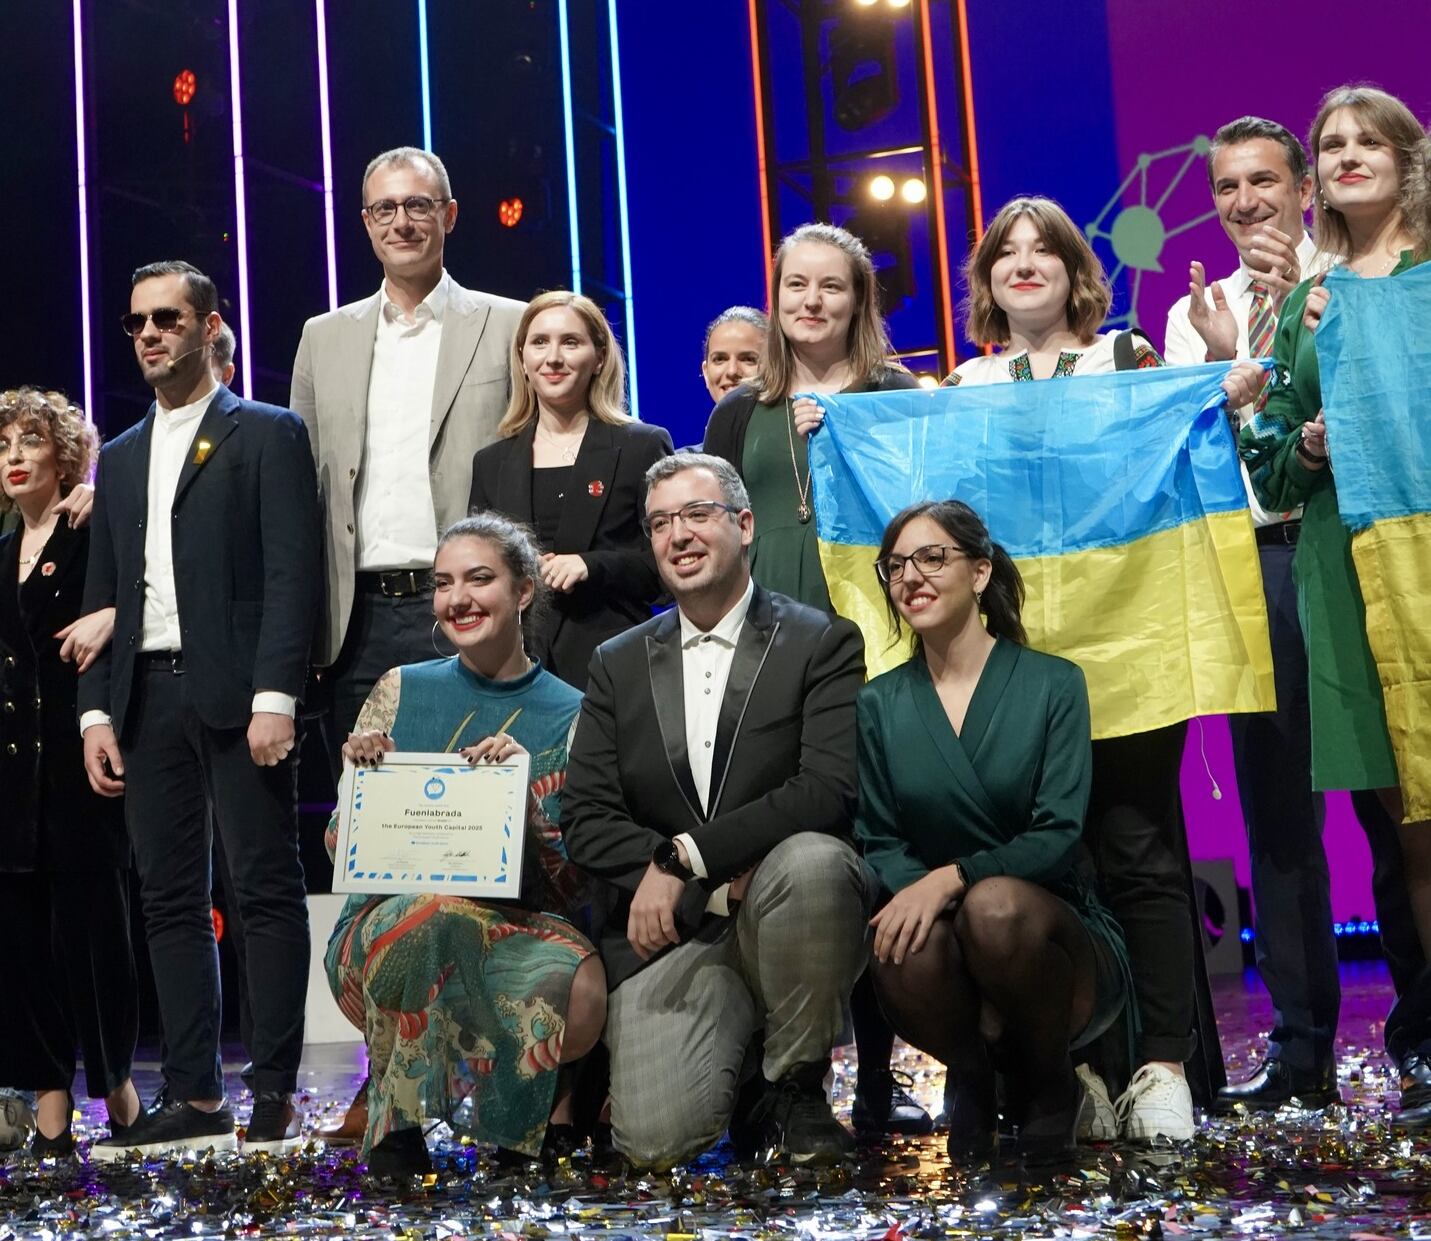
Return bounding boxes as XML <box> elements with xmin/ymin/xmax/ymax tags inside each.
<box><xmin>0</xmin><ymin>864</ymin><xmax>139</xmax><ymax>1099</ymax></box>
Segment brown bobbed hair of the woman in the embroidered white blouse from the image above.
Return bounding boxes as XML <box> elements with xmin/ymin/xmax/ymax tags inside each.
<box><xmin>964</xmin><ymin>195</ymin><xmax>1113</xmax><ymax>345</ymax></box>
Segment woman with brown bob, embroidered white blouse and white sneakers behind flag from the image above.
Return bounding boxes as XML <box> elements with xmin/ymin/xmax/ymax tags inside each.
<box><xmin>944</xmin><ymin>198</ymin><xmax>1261</xmax><ymax>1141</ymax></box>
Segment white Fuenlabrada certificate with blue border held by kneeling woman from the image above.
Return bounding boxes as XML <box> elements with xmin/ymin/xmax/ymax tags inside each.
<box><xmin>333</xmin><ymin>753</ymin><xmax>531</xmax><ymax>900</ymax></box>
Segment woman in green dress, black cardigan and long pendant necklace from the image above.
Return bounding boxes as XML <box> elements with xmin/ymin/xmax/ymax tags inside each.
<box><xmin>704</xmin><ymin>223</ymin><xmax>933</xmax><ymax>1137</ymax></box>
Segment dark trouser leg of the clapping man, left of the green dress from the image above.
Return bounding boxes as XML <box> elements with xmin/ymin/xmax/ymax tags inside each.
<box><xmin>1228</xmin><ymin>542</ymin><xmax>1333</xmax><ymax>1069</ymax></box>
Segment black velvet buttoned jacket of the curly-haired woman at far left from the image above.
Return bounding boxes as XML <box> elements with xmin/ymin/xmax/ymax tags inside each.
<box><xmin>0</xmin><ymin>517</ymin><xmax>129</xmax><ymax>872</ymax></box>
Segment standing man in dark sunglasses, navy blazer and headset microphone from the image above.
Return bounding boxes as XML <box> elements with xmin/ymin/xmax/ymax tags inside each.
<box><xmin>79</xmin><ymin>262</ymin><xmax>322</xmax><ymax>1159</ymax></box>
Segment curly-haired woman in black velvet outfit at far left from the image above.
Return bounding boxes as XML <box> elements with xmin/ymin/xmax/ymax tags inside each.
<box><xmin>0</xmin><ymin>388</ymin><xmax>139</xmax><ymax>1157</ymax></box>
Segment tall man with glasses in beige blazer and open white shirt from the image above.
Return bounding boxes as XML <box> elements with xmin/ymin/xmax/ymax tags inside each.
<box><xmin>289</xmin><ymin>146</ymin><xmax>522</xmax><ymax>776</ymax></box>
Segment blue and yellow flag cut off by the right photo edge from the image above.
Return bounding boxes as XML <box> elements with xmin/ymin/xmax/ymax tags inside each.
<box><xmin>1315</xmin><ymin>263</ymin><xmax>1431</xmax><ymax>823</ymax></box>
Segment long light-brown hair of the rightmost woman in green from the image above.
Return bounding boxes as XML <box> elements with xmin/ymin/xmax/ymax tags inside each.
<box><xmin>1307</xmin><ymin>86</ymin><xmax>1431</xmax><ymax>258</ymax></box>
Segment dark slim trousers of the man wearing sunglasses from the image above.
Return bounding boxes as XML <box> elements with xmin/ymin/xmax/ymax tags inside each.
<box><xmin>120</xmin><ymin>660</ymin><xmax>309</xmax><ymax>1099</ymax></box>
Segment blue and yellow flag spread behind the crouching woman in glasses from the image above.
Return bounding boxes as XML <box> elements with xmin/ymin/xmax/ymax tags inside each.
<box><xmin>810</xmin><ymin>364</ymin><xmax>1275</xmax><ymax>737</ymax></box>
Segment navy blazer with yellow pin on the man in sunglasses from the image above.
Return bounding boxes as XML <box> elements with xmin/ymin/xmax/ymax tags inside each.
<box><xmin>79</xmin><ymin>386</ymin><xmax>322</xmax><ymax>740</ymax></box>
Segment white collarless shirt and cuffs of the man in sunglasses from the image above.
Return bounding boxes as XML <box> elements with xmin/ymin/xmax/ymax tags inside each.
<box><xmin>80</xmin><ymin>384</ymin><xmax>298</xmax><ymax>733</ymax></box>
